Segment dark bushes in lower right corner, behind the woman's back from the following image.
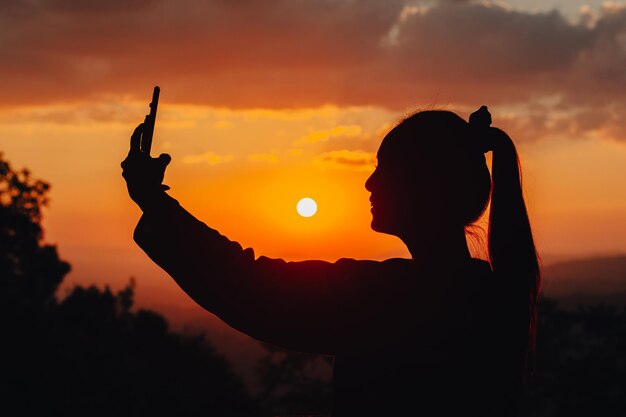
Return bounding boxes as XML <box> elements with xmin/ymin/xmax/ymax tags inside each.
<box><xmin>521</xmin><ymin>298</ymin><xmax>626</xmax><ymax>417</ymax></box>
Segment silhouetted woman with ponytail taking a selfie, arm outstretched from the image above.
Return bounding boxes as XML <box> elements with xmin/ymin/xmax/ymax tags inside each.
<box><xmin>122</xmin><ymin>106</ymin><xmax>539</xmax><ymax>417</ymax></box>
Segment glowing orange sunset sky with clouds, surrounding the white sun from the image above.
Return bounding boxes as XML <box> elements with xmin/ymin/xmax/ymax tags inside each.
<box><xmin>0</xmin><ymin>0</ymin><xmax>626</xmax><ymax>324</ymax></box>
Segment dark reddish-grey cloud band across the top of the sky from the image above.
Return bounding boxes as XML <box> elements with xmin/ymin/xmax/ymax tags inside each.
<box><xmin>0</xmin><ymin>0</ymin><xmax>626</xmax><ymax>140</ymax></box>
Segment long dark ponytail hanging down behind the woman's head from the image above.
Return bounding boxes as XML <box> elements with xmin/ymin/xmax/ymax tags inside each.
<box><xmin>470</xmin><ymin>106</ymin><xmax>541</xmax><ymax>377</ymax></box>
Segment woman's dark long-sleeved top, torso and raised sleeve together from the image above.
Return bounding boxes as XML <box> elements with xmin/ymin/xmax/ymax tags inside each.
<box><xmin>135</xmin><ymin>193</ymin><xmax>519</xmax><ymax>417</ymax></box>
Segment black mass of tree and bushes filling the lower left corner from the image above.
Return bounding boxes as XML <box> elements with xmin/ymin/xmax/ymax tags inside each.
<box><xmin>0</xmin><ymin>156</ymin><xmax>259</xmax><ymax>417</ymax></box>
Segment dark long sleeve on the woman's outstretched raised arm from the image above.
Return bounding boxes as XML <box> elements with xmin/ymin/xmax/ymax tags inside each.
<box><xmin>134</xmin><ymin>193</ymin><xmax>386</xmax><ymax>354</ymax></box>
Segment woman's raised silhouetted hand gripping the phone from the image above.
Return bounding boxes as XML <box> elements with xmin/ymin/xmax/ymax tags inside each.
<box><xmin>122</xmin><ymin>123</ymin><xmax>172</xmax><ymax>211</ymax></box>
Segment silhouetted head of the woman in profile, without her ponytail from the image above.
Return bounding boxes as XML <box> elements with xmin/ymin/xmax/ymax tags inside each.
<box><xmin>365</xmin><ymin>111</ymin><xmax>491</xmax><ymax>238</ymax></box>
